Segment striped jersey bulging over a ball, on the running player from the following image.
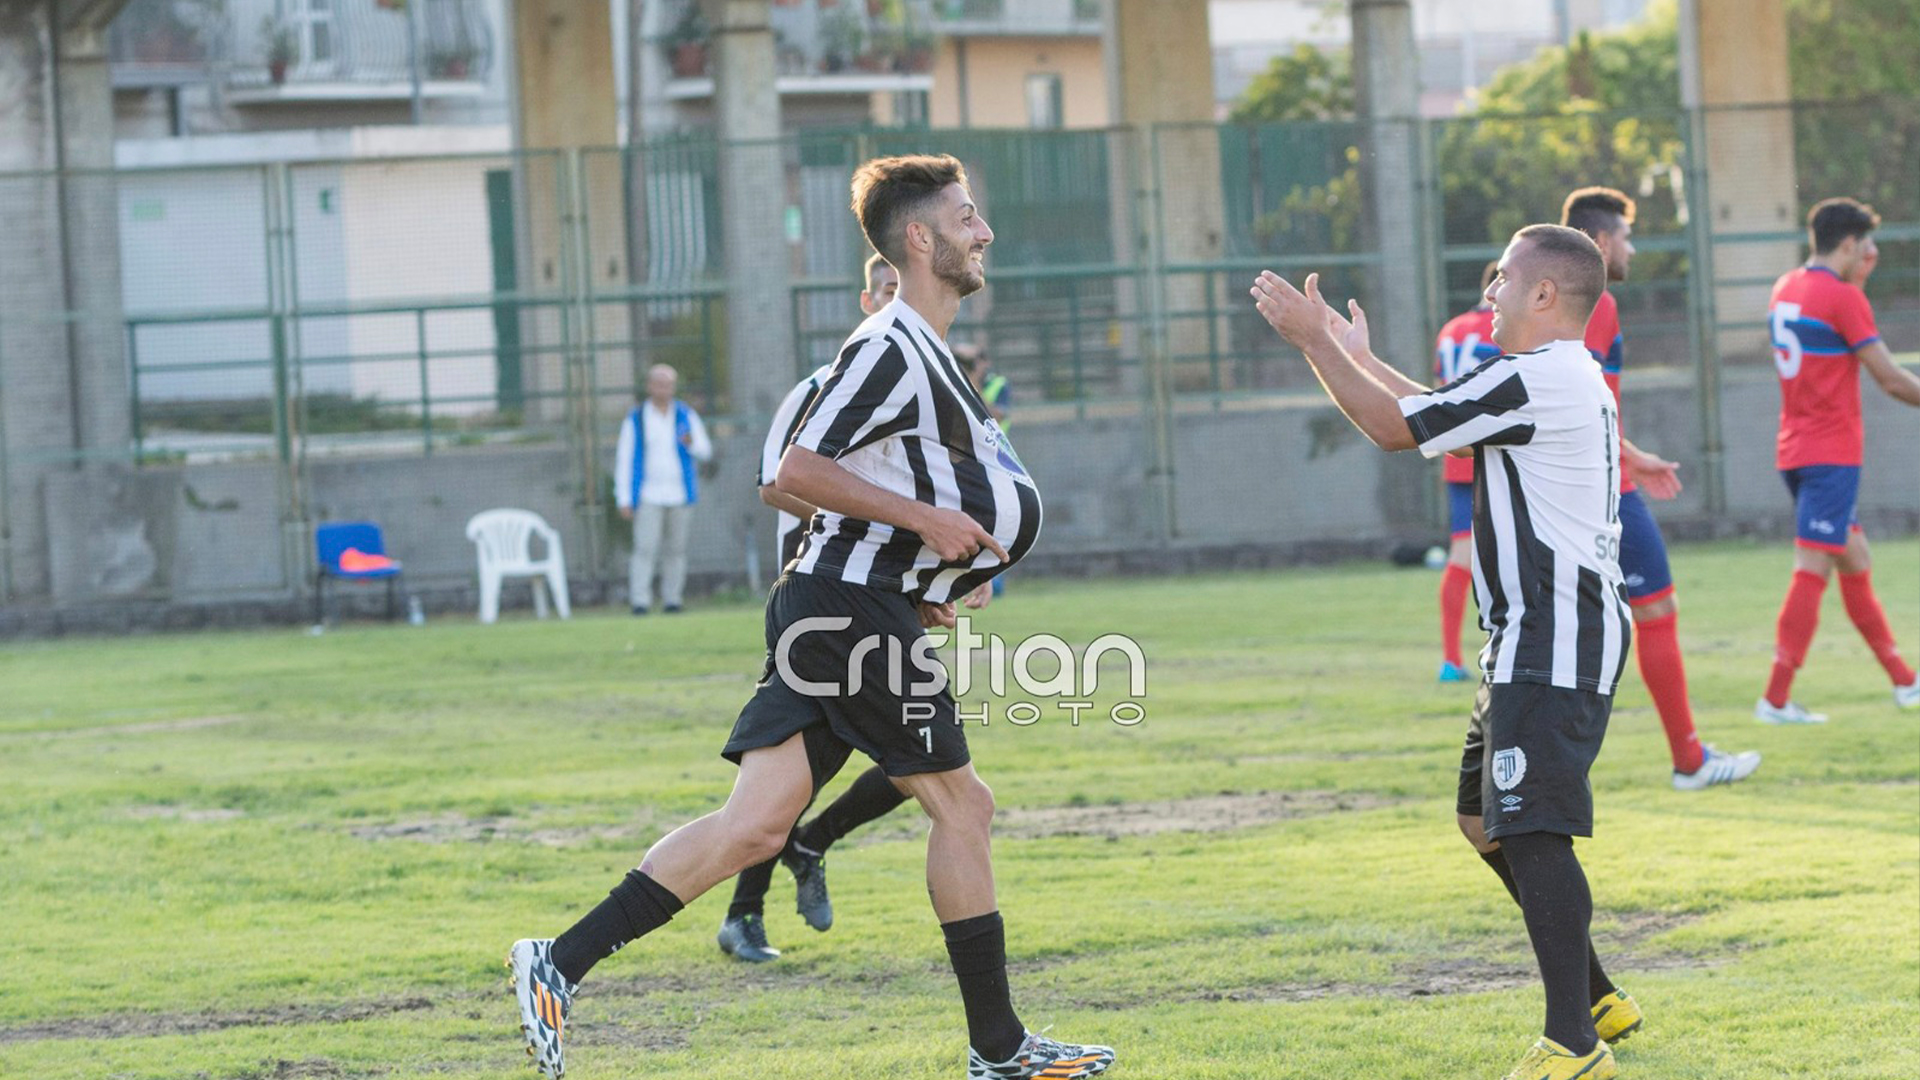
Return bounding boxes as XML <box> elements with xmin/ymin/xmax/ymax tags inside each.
<box><xmin>793</xmin><ymin>300</ymin><xmax>1041</xmax><ymax>603</ymax></box>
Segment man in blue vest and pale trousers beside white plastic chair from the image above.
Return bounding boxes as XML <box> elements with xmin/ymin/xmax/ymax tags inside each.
<box><xmin>612</xmin><ymin>363</ymin><xmax>714</xmax><ymax>615</ymax></box>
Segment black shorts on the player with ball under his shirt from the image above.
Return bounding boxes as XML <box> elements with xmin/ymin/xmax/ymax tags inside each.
<box><xmin>720</xmin><ymin>573</ymin><xmax>972</xmax><ymax>772</ymax></box>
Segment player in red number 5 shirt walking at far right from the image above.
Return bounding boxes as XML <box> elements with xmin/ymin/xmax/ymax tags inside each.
<box><xmin>1753</xmin><ymin>198</ymin><xmax>1920</xmax><ymax>724</ymax></box>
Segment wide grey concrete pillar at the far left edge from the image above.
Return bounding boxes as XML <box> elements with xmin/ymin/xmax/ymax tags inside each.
<box><xmin>0</xmin><ymin>2</ymin><xmax>133</xmax><ymax>603</ymax></box>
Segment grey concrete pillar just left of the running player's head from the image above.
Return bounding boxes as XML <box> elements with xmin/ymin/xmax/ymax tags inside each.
<box><xmin>707</xmin><ymin>0</ymin><xmax>791</xmax><ymax>417</ymax></box>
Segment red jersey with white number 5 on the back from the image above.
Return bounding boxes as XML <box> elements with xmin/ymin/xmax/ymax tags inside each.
<box><xmin>1766</xmin><ymin>267</ymin><xmax>1880</xmax><ymax>469</ymax></box>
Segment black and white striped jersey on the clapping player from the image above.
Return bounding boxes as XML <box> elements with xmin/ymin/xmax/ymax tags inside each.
<box><xmin>1400</xmin><ymin>340</ymin><xmax>1632</xmax><ymax>694</ymax></box>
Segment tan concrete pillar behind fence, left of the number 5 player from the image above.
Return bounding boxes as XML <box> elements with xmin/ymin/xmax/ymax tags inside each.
<box><xmin>1680</xmin><ymin>0</ymin><xmax>1797</xmax><ymax>356</ymax></box>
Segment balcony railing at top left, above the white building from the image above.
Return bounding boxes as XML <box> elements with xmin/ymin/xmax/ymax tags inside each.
<box><xmin>109</xmin><ymin>0</ymin><xmax>495</xmax><ymax>96</ymax></box>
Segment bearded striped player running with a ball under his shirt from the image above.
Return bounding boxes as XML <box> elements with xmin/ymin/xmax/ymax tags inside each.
<box><xmin>509</xmin><ymin>156</ymin><xmax>1114</xmax><ymax>1080</ymax></box>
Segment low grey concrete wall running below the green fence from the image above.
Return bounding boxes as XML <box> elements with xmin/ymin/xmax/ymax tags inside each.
<box><xmin>11</xmin><ymin>363</ymin><xmax>1920</xmax><ymax>636</ymax></box>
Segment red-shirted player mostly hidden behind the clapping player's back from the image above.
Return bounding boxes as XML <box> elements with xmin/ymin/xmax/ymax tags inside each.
<box><xmin>1561</xmin><ymin>188</ymin><xmax>1761</xmax><ymax>792</ymax></box>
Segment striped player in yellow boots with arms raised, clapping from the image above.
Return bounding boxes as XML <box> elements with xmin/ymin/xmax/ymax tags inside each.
<box><xmin>1252</xmin><ymin>225</ymin><xmax>1640</xmax><ymax>1080</ymax></box>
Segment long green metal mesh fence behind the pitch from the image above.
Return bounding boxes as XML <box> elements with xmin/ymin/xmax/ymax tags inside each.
<box><xmin>0</xmin><ymin>100</ymin><xmax>1920</xmax><ymax>607</ymax></box>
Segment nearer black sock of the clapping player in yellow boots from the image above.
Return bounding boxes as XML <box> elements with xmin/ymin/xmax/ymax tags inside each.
<box><xmin>1500</xmin><ymin>832</ymin><xmax>1597</xmax><ymax>1053</ymax></box>
